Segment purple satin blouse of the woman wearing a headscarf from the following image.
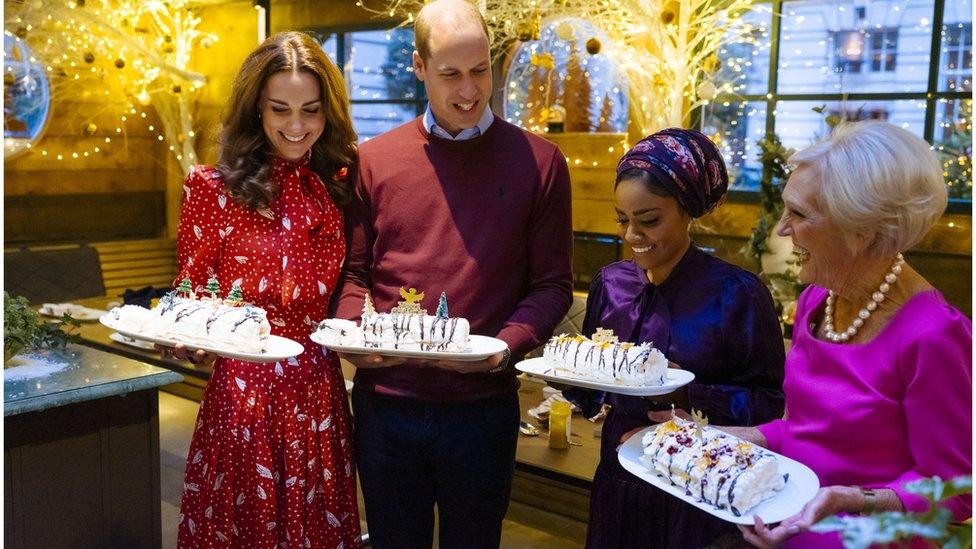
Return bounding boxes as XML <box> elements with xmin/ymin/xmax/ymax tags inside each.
<box><xmin>567</xmin><ymin>245</ymin><xmax>785</xmax><ymax>425</ymax></box>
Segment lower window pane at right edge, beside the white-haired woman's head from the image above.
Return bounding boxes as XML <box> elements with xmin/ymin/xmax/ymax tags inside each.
<box><xmin>933</xmin><ymin>99</ymin><xmax>973</xmax><ymax>200</ymax></box>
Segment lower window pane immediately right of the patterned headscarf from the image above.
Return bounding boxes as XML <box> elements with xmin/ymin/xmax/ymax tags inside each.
<box><xmin>702</xmin><ymin>101</ymin><xmax>766</xmax><ymax>191</ymax></box>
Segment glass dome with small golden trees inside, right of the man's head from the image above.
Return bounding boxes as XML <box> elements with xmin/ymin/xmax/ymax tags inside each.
<box><xmin>504</xmin><ymin>17</ymin><xmax>627</xmax><ymax>132</ymax></box>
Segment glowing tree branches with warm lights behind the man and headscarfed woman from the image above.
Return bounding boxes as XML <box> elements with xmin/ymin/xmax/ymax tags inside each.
<box><xmin>357</xmin><ymin>0</ymin><xmax>769</xmax><ymax>135</ymax></box>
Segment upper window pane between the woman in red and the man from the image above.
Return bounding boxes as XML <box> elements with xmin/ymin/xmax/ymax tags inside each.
<box><xmin>345</xmin><ymin>28</ymin><xmax>417</xmax><ymax>101</ymax></box>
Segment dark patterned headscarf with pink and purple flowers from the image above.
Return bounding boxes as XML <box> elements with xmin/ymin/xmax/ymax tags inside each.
<box><xmin>617</xmin><ymin>128</ymin><xmax>729</xmax><ymax>218</ymax></box>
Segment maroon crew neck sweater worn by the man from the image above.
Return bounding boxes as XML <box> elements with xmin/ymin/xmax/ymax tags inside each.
<box><xmin>333</xmin><ymin>116</ymin><xmax>573</xmax><ymax>401</ymax></box>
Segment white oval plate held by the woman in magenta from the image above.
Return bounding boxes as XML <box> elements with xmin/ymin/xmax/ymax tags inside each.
<box><xmin>617</xmin><ymin>425</ymin><xmax>820</xmax><ymax>525</ymax></box>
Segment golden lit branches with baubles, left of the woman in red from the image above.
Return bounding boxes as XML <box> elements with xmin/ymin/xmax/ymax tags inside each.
<box><xmin>4</xmin><ymin>0</ymin><xmax>217</xmax><ymax>171</ymax></box>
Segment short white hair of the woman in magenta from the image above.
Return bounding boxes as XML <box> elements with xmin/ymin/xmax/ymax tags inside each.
<box><xmin>790</xmin><ymin>120</ymin><xmax>948</xmax><ymax>258</ymax></box>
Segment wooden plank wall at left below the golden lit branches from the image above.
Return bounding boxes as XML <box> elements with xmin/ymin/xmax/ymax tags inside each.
<box><xmin>4</xmin><ymin>101</ymin><xmax>168</xmax><ymax>244</ymax></box>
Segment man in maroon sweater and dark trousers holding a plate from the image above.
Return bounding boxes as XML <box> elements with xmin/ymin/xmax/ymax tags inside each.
<box><xmin>334</xmin><ymin>0</ymin><xmax>572</xmax><ymax>549</ymax></box>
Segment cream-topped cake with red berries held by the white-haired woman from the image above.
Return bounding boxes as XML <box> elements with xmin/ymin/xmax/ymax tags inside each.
<box><xmin>640</xmin><ymin>415</ymin><xmax>788</xmax><ymax>517</ymax></box>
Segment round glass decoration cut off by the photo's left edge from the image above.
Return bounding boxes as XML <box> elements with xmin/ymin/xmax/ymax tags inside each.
<box><xmin>3</xmin><ymin>32</ymin><xmax>51</xmax><ymax>158</ymax></box>
